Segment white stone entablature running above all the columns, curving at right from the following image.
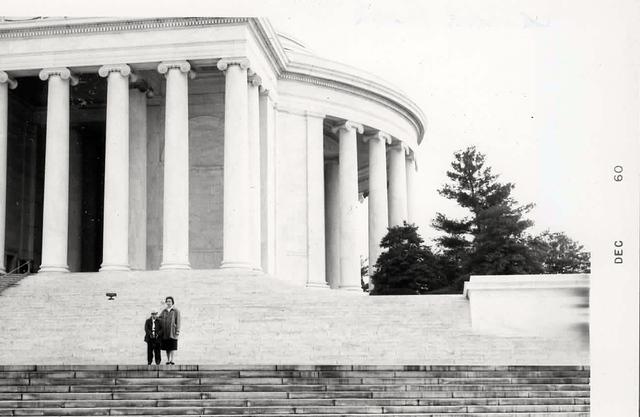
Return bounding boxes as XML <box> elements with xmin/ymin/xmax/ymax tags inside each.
<box><xmin>0</xmin><ymin>17</ymin><xmax>425</xmax><ymax>147</ymax></box>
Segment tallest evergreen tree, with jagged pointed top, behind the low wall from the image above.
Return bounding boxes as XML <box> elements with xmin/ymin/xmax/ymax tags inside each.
<box><xmin>433</xmin><ymin>146</ymin><xmax>543</xmax><ymax>290</ymax></box>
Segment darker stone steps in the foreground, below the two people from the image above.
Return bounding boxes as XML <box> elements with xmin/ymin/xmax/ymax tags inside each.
<box><xmin>0</xmin><ymin>365</ymin><xmax>589</xmax><ymax>417</ymax></box>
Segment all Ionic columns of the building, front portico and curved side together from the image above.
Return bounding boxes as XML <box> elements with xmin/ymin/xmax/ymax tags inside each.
<box><xmin>0</xmin><ymin>59</ymin><xmax>415</xmax><ymax>282</ymax></box>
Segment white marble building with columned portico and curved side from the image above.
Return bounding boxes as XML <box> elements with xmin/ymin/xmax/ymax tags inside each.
<box><xmin>0</xmin><ymin>18</ymin><xmax>425</xmax><ymax>290</ymax></box>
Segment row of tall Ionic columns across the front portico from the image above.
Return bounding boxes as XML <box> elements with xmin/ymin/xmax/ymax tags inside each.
<box><xmin>0</xmin><ymin>59</ymin><xmax>263</xmax><ymax>272</ymax></box>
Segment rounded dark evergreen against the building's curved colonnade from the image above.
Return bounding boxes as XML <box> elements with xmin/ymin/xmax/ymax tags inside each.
<box><xmin>370</xmin><ymin>222</ymin><xmax>446</xmax><ymax>295</ymax></box>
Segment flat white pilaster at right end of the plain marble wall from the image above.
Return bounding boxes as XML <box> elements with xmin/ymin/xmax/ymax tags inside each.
<box><xmin>305</xmin><ymin>112</ymin><xmax>328</xmax><ymax>288</ymax></box>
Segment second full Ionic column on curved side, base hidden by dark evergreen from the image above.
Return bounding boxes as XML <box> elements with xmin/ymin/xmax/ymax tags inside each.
<box><xmin>364</xmin><ymin>132</ymin><xmax>391</xmax><ymax>276</ymax></box>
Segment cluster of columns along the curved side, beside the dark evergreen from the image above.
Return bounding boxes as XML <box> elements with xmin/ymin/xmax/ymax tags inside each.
<box><xmin>325</xmin><ymin>121</ymin><xmax>416</xmax><ymax>291</ymax></box>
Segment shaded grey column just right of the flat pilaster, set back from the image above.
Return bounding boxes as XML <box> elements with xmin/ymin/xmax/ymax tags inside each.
<box><xmin>324</xmin><ymin>159</ymin><xmax>340</xmax><ymax>288</ymax></box>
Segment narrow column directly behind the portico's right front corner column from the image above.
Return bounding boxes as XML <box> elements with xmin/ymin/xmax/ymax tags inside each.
<box><xmin>247</xmin><ymin>74</ymin><xmax>262</xmax><ymax>270</ymax></box>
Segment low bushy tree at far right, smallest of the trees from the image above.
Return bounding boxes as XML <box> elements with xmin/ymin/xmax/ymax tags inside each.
<box><xmin>528</xmin><ymin>230</ymin><xmax>591</xmax><ymax>274</ymax></box>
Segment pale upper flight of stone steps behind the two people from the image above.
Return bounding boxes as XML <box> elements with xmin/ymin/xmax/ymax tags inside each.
<box><xmin>0</xmin><ymin>270</ymin><xmax>589</xmax><ymax>365</ymax></box>
